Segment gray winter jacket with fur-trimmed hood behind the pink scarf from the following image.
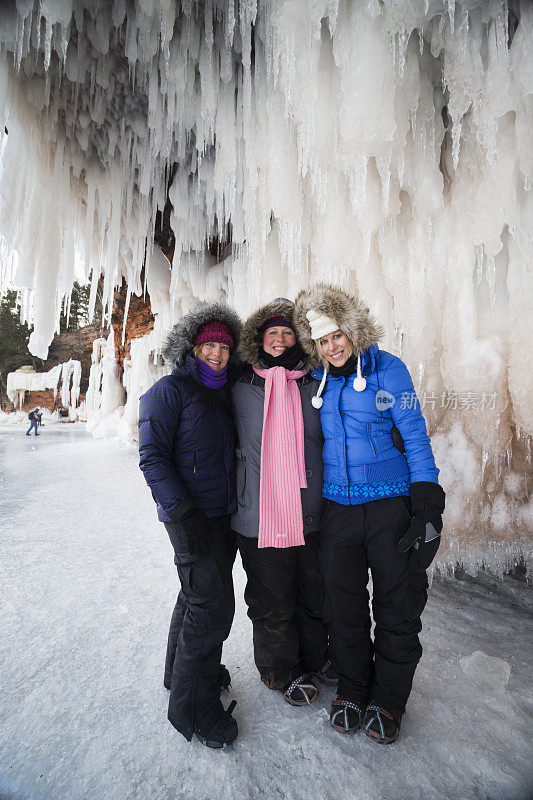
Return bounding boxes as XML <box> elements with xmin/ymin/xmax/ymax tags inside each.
<box><xmin>231</xmin><ymin>301</ymin><xmax>324</xmax><ymax>538</ymax></box>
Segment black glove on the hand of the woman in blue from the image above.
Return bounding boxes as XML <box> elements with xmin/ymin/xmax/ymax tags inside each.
<box><xmin>398</xmin><ymin>481</ymin><xmax>446</xmax><ymax>571</ymax></box>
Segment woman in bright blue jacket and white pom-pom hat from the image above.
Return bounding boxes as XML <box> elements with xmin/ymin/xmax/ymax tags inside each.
<box><xmin>294</xmin><ymin>284</ymin><xmax>444</xmax><ymax>744</ymax></box>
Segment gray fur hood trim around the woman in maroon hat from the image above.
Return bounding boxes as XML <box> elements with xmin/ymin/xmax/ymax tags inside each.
<box><xmin>162</xmin><ymin>301</ymin><xmax>242</xmax><ymax>364</ymax></box>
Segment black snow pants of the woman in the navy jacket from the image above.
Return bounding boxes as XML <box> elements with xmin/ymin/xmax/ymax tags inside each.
<box><xmin>164</xmin><ymin>516</ymin><xmax>237</xmax><ymax>741</ymax></box>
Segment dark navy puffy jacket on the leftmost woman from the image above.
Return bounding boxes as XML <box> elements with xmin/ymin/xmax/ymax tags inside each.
<box><xmin>139</xmin><ymin>354</ymin><xmax>237</xmax><ymax>522</ymax></box>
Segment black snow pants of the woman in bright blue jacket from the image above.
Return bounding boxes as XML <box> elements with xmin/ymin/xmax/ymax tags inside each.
<box><xmin>320</xmin><ymin>497</ymin><xmax>427</xmax><ymax>713</ymax></box>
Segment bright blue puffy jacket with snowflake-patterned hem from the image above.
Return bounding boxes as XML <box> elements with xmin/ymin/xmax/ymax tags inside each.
<box><xmin>312</xmin><ymin>344</ymin><xmax>439</xmax><ymax>502</ymax></box>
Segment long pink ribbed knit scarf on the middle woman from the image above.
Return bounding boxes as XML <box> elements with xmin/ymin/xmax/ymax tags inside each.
<box><xmin>254</xmin><ymin>367</ymin><xmax>307</xmax><ymax>547</ymax></box>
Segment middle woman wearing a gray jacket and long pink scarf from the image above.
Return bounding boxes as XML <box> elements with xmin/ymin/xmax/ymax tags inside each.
<box><xmin>232</xmin><ymin>299</ymin><xmax>327</xmax><ymax>706</ymax></box>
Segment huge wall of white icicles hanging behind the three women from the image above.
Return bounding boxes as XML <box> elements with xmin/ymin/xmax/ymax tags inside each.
<box><xmin>0</xmin><ymin>0</ymin><xmax>533</xmax><ymax>572</ymax></box>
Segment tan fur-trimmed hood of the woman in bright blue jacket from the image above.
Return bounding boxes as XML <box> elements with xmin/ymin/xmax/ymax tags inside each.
<box><xmin>293</xmin><ymin>283</ymin><xmax>384</xmax><ymax>366</ymax></box>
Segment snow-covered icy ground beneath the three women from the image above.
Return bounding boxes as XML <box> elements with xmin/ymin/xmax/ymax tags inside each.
<box><xmin>0</xmin><ymin>424</ymin><xmax>533</xmax><ymax>800</ymax></box>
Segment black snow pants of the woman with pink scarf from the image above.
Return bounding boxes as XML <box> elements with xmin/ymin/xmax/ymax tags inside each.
<box><xmin>237</xmin><ymin>533</ymin><xmax>328</xmax><ymax>689</ymax></box>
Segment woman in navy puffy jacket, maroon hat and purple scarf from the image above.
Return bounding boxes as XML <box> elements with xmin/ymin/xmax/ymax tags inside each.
<box><xmin>139</xmin><ymin>303</ymin><xmax>241</xmax><ymax>748</ymax></box>
